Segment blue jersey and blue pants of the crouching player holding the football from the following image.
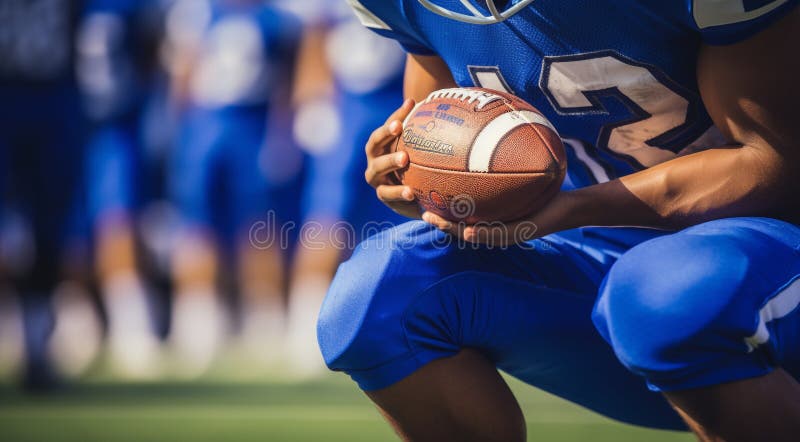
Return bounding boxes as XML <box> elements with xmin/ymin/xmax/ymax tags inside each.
<box><xmin>318</xmin><ymin>0</ymin><xmax>800</xmax><ymax>429</ymax></box>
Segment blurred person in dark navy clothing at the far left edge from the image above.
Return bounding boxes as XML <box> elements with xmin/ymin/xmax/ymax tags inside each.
<box><xmin>0</xmin><ymin>0</ymin><xmax>85</xmax><ymax>387</ymax></box>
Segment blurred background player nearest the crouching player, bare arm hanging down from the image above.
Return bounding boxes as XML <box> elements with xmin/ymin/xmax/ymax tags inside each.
<box><xmin>282</xmin><ymin>1</ymin><xmax>405</xmax><ymax>376</ymax></box>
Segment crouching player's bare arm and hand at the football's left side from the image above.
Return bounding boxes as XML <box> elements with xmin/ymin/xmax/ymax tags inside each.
<box><xmin>364</xmin><ymin>54</ymin><xmax>455</xmax><ymax>218</ymax></box>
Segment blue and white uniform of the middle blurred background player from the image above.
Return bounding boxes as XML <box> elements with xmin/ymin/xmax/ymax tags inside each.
<box><xmin>170</xmin><ymin>1</ymin><xmax>301</xmax><ymax>243</ymax></box>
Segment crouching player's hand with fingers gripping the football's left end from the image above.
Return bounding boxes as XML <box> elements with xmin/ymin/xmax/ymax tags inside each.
<box><xmin>364</xmin><ymin>99</ymin><xmax>420</xmax><ymax>218</ymax></box>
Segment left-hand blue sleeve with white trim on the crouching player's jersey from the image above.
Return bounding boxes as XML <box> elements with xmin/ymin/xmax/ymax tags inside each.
<box><xmin>347</xmin><ymin>0</ymin><xmax>435</xmax><ymax>55</ymax></box>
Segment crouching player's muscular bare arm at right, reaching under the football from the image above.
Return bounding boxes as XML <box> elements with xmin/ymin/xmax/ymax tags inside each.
<box><xmin>454</xmin><ymin>8</ymin><xmax>800</xmax><ymax>245</ymax></box>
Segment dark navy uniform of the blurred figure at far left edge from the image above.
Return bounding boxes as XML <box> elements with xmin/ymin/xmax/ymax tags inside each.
<box><xmin>0</xmin><ymin>0</ymin><xmax>82</xmax><ymax>276</ymax></box>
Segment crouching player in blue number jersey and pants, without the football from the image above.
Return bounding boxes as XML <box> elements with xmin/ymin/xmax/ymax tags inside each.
<box><xmin>318</xmin><ymin>0</ymin><xmax>800</xmax><ymax>441</ymax></box>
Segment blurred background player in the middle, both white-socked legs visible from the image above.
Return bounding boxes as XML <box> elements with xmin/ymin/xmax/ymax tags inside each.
<box><xmin>168</xmin><ymin>0</ymin><xmax>300</xmax><ymax>374</ymax></box>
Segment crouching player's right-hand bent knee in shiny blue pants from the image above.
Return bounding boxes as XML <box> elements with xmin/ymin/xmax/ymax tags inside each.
<box><xmin>593</xmin><ymin>232</ymin><xmax>750</xmax><ymax>378</ymax></box>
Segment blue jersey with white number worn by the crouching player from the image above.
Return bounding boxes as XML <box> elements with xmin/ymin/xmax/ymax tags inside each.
<box><xmin>349</xmin><ymin>0</ymin><xmax>798</xmax><ymax>187</ymax></box>
